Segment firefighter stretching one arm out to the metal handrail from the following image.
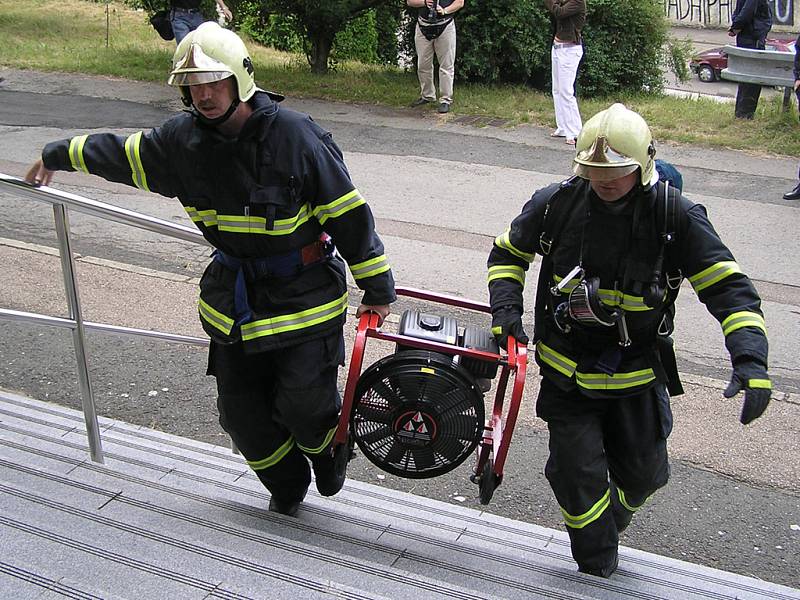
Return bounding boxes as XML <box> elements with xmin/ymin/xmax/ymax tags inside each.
<box><xmin>26</xmin><ymin>22</ymin><xmax>395</xmax><ymax>515</ymax></box>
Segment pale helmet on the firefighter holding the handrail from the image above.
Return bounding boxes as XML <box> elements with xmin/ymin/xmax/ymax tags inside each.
<box><xmin>167</xmin><ymin>21</ymin><xmax>258</xmax><ymax>102</ymax></box>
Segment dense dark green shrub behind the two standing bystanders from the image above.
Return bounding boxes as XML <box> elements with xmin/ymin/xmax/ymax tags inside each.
<box><xmin>402</xmin><ymin>0</ymin><xmax>674</xmax><ymax>96</ymax></box>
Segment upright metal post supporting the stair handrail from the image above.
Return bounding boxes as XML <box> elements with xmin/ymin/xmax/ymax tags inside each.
<box><xmin>53</xmin><ymin>202</ymin><xmax>104</xmax><ymax>463</ymax></box>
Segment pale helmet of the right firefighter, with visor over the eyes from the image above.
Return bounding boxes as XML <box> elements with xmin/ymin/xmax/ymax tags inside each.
<box><xmin>572</xmin><ymin>104</ymin><xmax>658</xmax><ymax>188</ymax></box>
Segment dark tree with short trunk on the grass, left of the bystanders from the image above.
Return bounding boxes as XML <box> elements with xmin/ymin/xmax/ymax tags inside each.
<box><xmin>228</xmin><ymin>0</ymin><xmax>397</xmax><ymax>74</ymax></box>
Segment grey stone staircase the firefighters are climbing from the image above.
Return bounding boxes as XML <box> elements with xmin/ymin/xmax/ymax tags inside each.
<box><xmin>0</xmin><ymin>390</ymin><xmax>800</xmax><ymax>600</ymax></box>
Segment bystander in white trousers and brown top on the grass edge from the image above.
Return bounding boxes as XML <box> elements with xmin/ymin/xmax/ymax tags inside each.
<box><xmin>544</xmin><ymin>0</ymin><xmax>586</xmax><ymax>145</ymax></box>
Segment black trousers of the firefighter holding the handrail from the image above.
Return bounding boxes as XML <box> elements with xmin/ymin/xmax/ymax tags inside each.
<box><xmin>208</xmin><ymin>329</ymin><xmax>344</xmax><ymax>501</ymax></box>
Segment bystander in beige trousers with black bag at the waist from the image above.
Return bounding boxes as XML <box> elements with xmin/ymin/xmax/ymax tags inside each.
<box><xmin>407</xmin><ymin>0</ymin><xmax>464</xmax><ymax>114</ymax></box>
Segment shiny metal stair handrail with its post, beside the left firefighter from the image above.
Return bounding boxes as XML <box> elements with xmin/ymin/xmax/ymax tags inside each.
<box><xmin>0</xmin><ymin>173</ymin><xmax>212</xmax><ymax>463</ymax></box>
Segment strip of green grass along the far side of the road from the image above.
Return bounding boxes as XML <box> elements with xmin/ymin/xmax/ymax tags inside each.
<box><xmin>0</xmin><ymin>0</ymin><xmax>800</xmax><ymax>156</ymax></box>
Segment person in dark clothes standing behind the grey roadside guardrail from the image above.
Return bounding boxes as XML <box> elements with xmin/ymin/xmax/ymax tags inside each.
<box><xmin>728</xmin><ymin>0</ymin><xmax>772</xmax><ymax>119</ymax></box>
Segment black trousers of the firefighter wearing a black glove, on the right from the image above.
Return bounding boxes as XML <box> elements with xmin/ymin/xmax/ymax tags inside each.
<box><xmin>536</xmin><ymin>378</ymin><xmax>672</xmax><ymax>570</ymax></box>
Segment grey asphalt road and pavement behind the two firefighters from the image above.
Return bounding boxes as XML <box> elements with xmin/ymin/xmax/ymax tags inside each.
<box><xmin>0</xmin><ymin>72</ymin><xmax>800</xmax><ymax>587</ymax></box>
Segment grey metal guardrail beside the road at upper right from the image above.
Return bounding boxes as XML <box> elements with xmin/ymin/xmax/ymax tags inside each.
<box><xmin>722</xmin><ymin>46</ymin><xmax>794</xmax><ymax>110</ymax></box>
